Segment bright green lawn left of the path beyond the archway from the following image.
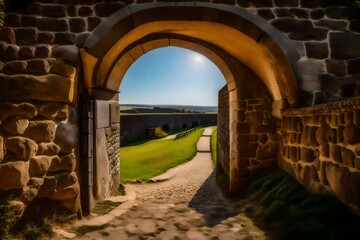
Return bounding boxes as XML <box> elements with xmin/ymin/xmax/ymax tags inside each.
<box><xmin>120</xmin><ymin>128</ymin><xmax>204</xmax><ymax>182</ymax></box>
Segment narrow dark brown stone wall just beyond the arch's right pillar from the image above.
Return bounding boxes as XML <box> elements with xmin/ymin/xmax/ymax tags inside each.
<box><xmin>217</xmin><ymin>85</ymin><xmax>230</xmax><ymax>176</ymax></box>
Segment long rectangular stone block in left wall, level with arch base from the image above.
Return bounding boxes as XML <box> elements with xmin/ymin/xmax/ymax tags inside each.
<box><xmin>0</xmin><ymin>74</ymin><xmax>74</xmax><ymax>103</ymax></box>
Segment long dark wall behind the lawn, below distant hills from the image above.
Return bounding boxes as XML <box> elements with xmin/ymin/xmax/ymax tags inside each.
<box><xmin>120</xmin><ymin>113</ymin><xmax>217</xmax><ymax>146</ymax></box>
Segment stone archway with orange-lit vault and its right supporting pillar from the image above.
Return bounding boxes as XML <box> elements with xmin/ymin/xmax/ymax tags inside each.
<box><xmin>81</xmin><ymin>3</ymin><xmax>299</xmax><ymax>212</ymax></box>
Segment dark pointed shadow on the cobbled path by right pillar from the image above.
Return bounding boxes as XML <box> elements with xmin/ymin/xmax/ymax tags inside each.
<box><xmin>189</xmin><ymin>170</ymin><xmax>239</xmax><ymax>227</ymax></box>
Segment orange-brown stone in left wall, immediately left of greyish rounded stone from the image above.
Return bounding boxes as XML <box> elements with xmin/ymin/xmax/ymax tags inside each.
<box><xmin>24</xmin><ymin>121</ymin><xmax>56</xmax><ymax>143</ymax></box>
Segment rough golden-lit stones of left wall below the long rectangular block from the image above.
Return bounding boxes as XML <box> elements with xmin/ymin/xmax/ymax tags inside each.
<box><xmin>0</xmin><ymin>102</ymin><xmax>80</xmax><ymax>218</ymax></box>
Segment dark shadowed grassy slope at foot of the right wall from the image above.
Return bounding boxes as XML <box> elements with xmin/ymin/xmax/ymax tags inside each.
<box><xmin>242</xmin><ymin>172</ymin><xmax>360</xmax><ymax>240</ymax></box>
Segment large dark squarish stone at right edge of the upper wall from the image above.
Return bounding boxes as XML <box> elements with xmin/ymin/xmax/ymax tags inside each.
<box><xmin>329</xmin><ymin>32</ymin><xmax>360</xmax><ymax>59</ymax></box>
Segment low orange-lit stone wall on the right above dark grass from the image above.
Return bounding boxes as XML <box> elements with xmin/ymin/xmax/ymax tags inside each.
<box><xmin>279</xmin><ymin>98</ymin><xmax>360</xmax><ymax>210</ymax></box>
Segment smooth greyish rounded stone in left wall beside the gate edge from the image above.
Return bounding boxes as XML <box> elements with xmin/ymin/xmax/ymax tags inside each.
<box><xmin>54</xmin><ymin>123</ymin><xmax>78</xmax><ymax>153</ymax></box>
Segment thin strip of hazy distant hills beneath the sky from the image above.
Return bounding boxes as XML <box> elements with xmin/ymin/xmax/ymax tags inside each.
<box><xmin>120</xmin><ymin>104</ymin><xmax>218</xmax><ymax>113</ymax></box>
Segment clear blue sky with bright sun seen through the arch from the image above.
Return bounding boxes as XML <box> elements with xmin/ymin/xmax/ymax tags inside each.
<box><xmin>120</xmin><ymin>47</ymin><xmax>226</xmax><ymax>106</ymax></box>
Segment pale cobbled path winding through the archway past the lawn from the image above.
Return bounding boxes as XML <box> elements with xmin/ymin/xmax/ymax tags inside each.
<box><xmin>80</xmin><ymin>128</ymin><xmax>265</xmax><ymax>240</ymax></box>
